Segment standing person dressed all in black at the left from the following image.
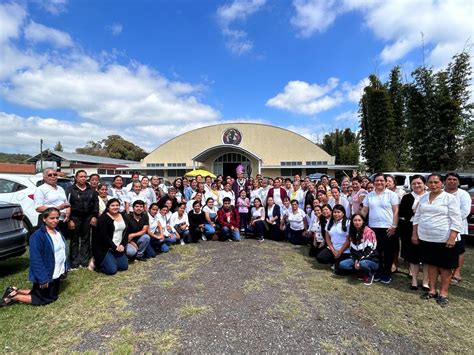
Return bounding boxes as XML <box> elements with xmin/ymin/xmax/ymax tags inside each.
<box><xmin>66</xmin><ymin>170</ymin><xmax>99</xmax><ymax>269</ymax></box>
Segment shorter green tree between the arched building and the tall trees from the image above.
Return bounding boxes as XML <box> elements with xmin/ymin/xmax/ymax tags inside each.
<box><xmin>322</xmin><ymin>128</ymin><xmax>360</xmax><ymax>165</ymax></box>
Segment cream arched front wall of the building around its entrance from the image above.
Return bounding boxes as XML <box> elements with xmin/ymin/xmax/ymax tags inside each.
<box><xmin>143</xmin><ymin>123</ymin><xmax>335</xmax><ymax>168</ymax></box>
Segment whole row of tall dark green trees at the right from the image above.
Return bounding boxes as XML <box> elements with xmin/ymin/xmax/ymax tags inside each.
<box><xmin>359</xmin><ymin>52</ymin><xmax>474</xmax><ymax>171</ymax></box>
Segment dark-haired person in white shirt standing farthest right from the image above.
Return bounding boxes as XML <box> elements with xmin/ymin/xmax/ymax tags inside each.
<box><xmin>444</xmin><ymin>172</ymin><xmax>472</xmax><ymax>282</ymax></box>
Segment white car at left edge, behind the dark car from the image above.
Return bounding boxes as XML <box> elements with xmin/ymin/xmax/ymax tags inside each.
<box><xmin>0</xmin><ymin>174</ymin><xmax>72</xmax><ymax>234</ymax></box>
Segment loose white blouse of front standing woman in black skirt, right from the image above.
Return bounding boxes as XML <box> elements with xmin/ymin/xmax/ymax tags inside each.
<box><xmin>413</xmin><ymin>191</ymin><xmax>462</xmax><ymax>243</ymax></box>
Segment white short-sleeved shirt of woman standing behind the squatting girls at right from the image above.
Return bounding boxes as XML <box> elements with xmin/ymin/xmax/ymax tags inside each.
<box><xmin>363</xmin><ymin>189</ymin><xmax>399</xmax><ymax>228</ymax></box>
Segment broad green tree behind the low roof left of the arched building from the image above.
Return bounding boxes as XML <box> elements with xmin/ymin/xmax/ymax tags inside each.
<box><xmin>76</xmin><ymin>135</ymin><xmax>148</xmax><ymax>161</ymax></box>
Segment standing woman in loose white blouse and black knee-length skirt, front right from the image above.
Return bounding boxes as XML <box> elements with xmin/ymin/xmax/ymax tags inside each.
<box><xmin>412</xmin><ymin>174</ymin><xmax>462</xmax><ymax>307</ymax></box>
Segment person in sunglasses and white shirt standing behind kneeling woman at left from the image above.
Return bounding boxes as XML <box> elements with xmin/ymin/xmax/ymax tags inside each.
<box><xmin>35</xmin><ymin>168</ymin><xmax>71</xmax><ymax>227</ymax></box>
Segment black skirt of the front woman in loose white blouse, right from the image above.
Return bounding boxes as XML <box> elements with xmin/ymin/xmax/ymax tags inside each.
<box><xmin>420</xmin><ymin>240</ymin><xmax>459</xmax><ymax>269</ymax></box>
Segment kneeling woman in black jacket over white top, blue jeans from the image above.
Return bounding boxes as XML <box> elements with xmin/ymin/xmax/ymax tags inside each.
<box><xmin>92</xmin><ymin>198</ymin><xmax>128</xmax><ymax>275</ymax></box>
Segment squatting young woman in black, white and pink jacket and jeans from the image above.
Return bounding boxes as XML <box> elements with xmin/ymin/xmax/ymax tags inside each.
<box><xmin>339</xmin><ymin>214</ymin><xmax>379</xmax><ymax>285</ymax></box>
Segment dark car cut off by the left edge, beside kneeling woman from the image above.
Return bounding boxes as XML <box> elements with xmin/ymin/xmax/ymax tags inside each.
<box><xmin>0</xmin><ymin>202</ymin><xmax>28</xmax><ymax>260</ymax></box>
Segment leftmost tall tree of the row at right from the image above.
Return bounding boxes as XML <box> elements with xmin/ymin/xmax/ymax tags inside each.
<box><xmin>359</xmin><ymin>75</ymin><xmax>396</xmax><ymax>171</ymax></box>
